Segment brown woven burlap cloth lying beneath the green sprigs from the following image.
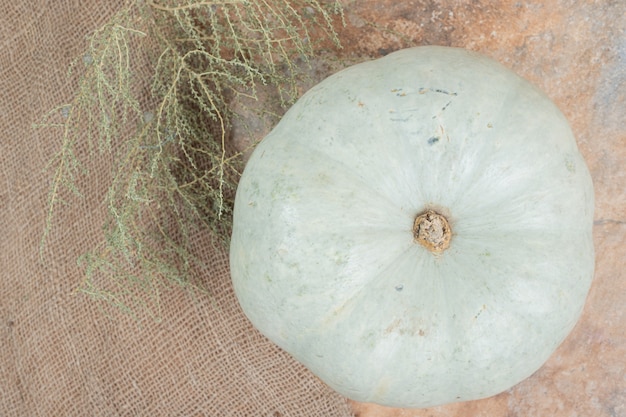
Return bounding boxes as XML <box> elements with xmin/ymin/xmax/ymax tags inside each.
<box><xmin>0</xmin><ymin>0</ymin><xmax>351</xmax><ymax>417</ymax></box>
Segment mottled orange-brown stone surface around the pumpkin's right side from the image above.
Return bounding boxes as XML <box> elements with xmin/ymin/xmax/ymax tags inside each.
<box><xmin>332</xmin><ymin>0</ymin><xmax>626</xmax><ymax>417</ymax></box>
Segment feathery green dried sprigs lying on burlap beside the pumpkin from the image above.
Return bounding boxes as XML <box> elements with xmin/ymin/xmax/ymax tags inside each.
<box><xmin>38</xmin><ymin>0</ymin><xmax>342</xmax><ymax>318</ymax></box>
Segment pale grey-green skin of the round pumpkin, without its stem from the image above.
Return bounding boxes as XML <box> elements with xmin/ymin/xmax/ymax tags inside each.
<box><xmin>230</xmin><ymin>46</ymin><xmax>594</xmax><ymax>407</ymax></box>
